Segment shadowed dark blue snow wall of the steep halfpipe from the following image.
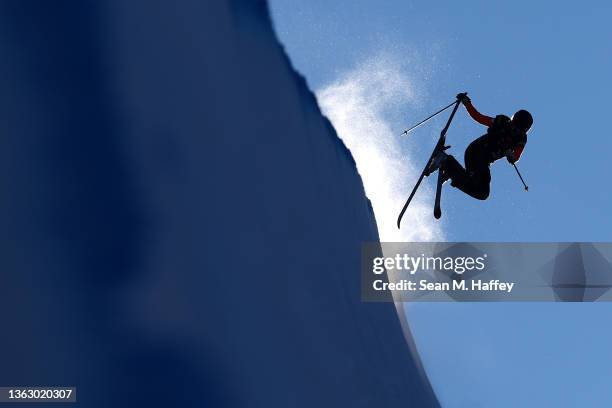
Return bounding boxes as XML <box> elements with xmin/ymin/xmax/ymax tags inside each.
<box><xmin>0</xmin><ymin>0</ymin><xmax>437</xmax><ymax>407</ymax></box>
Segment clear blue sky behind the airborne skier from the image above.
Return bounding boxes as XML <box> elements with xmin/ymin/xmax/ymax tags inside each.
<box><xmin>271</xmin><ymin>0</ymin><xmax>612</xmax><ymax>407</ymax></box>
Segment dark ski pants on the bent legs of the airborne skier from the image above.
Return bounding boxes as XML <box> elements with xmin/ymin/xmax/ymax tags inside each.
<box><xmin>442</xmin><ymin>139</ymin><xmax>491</xmax><ymax>200</ymax></box>
